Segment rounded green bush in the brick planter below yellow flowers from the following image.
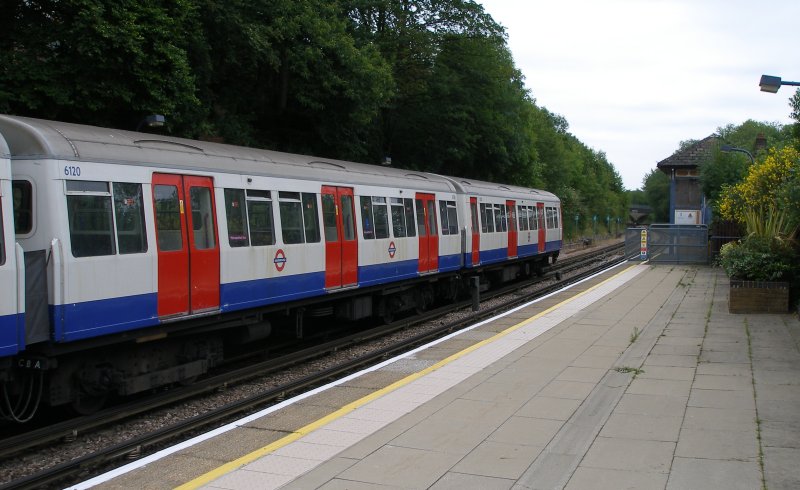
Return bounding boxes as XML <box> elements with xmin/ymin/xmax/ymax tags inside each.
<box><xmin>718</xmin><ymin>235</ymin><xmax>797</xmax><ymax>281</ymax></box>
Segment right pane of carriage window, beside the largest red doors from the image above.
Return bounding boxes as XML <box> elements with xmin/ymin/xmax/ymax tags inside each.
<box><xmin>112</xmin><ymin>182</ymin><xmax>147</xmax><ymax>254</ymax></box>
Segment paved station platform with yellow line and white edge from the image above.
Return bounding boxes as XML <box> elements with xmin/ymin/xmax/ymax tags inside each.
<box><xmin>81</xmin><ymin>264</ymin><xmax>800</xmax><ymax>490</ymax></box>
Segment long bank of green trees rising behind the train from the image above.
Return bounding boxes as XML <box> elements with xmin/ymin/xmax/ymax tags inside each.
<box><xmin>0</xmin><ymin>0</ymin><xmax>628</xmax><ymax>237</ymax></box>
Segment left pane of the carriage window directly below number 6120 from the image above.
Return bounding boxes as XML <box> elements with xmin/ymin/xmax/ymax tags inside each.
<box><xmin>66</xmin><ymin>180</ymin><xmax>115</xmax><ymax>257</ymax></box>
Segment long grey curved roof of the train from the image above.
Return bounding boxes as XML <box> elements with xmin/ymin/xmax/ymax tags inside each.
<box><xmin>0</xmin><ymin>114</ymin><xmax>558</xmax><ymax>200</ymax></box>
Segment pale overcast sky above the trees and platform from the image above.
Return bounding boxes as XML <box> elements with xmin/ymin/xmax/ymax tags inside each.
<box><xmin>476</xmin><ymin>0</ymin><xmax>800</xmax><ymax>189</ymax></box>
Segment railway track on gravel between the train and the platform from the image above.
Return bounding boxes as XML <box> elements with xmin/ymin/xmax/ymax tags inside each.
<box><xmin>0</xmin><ymin>244</ymin><xmax>626</xmax><ymax>490</ymax></box>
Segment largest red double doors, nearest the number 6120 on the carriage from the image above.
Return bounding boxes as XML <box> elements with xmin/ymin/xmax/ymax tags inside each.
<box><xmin>153</xmin><ymin>174</ymin><xmax>219</xmax><ymax>317</ymax></box>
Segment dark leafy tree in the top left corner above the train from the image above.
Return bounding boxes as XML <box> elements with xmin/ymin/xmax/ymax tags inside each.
<box><xmin>0</xmin><ymin>0</ymin><xmax>203</xmax><ymax>130</ymax></box>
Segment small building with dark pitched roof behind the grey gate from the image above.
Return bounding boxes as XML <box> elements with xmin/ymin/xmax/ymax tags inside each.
<box><xmin>656</xmin><ymin>135</ymin><xmax>720</xmax><ymax>225</ymax></box>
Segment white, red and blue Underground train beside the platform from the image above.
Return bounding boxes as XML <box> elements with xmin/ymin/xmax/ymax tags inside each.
<box><xmin>0</xmin><ymin>115</ymin><xmax>562</xmax><ymax>422</ymax></box>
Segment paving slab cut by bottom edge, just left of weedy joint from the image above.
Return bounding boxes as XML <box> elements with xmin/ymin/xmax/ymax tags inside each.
<box><xmin>667</xmin><ymin>457</ymin><xmax>761</xmax><ymax>490</ymax></box>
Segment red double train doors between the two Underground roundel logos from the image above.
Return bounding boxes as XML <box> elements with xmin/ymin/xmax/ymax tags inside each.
<box><xmin>322</xmin><ymin>185</ymin><xmax>358</xmax><ymax>289</ymax></box>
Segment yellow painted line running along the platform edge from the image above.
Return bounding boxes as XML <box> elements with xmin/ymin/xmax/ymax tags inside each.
<box><xmin>176</xmin><ymin>264</ymin><xmax>636</xmax><ymax>490</ymax></box>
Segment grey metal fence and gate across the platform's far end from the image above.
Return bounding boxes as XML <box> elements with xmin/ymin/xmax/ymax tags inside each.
<box><xmin>625</xmin><ymin>224</ymin><xmax>709</xmax><ymax>264</ymax></box>
